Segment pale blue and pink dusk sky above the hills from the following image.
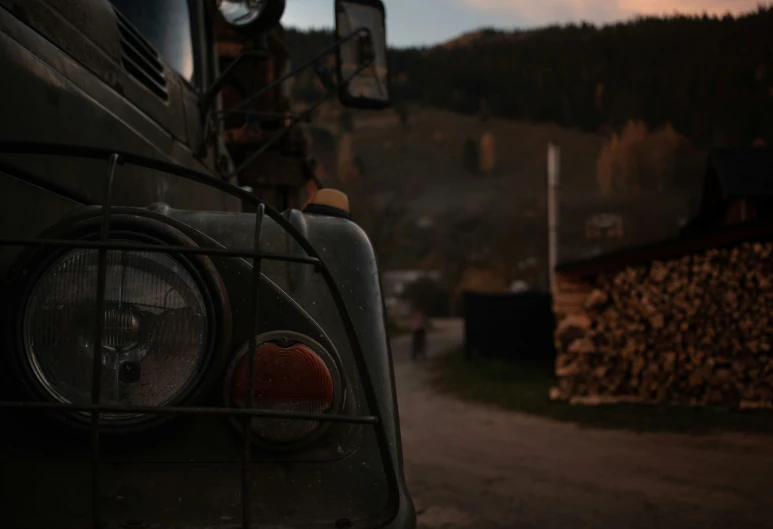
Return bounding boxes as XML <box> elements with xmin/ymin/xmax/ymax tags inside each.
<box><xmin>282</xmin><ymin>0</ymin><xmax>768</xmax><ymax>47</ymax></box>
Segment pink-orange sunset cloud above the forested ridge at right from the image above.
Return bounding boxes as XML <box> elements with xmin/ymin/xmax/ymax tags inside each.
<box><xmin>458</xmin><ymin>0</ymin><xmax>759</xmax><ymax>25</ymax></box>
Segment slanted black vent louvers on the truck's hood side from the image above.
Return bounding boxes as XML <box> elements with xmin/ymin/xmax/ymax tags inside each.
<box><xmin>114</xmin><ymin>9</ymin><xmax>169</xmax><ymax>101</ymax></box>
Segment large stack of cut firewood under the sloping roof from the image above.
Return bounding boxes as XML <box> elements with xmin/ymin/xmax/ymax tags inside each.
<box><xmin>552</xmin><ymin>242</ymin><xmax>773</xmax><ymax>407</ymax></box>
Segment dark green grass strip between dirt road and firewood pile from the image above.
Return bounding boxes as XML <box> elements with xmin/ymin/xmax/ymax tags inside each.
<box><xmin>430</xmin><ymin>350</ymin><xmax>773</xmax><ymax>435</ymax></box>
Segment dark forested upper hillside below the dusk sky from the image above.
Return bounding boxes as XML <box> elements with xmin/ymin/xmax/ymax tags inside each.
<box><xmin>289</xmin><ymin>7</ymin><xmax>773</xmax><ymax>147</ymax></box>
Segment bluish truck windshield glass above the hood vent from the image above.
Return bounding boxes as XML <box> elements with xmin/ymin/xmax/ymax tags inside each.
<box><xmin>110</xmin><ymin>0</ymin><xmax>197</xmax><ymax>85</ymax></box>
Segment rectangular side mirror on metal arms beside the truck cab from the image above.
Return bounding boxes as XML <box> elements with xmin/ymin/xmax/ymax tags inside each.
<box><xmin>335</xmin><ymin>0</ymin><xmax>391</xmax><ymax>109</ymax></box>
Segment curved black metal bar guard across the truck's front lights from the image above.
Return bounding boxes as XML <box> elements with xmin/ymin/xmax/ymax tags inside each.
<box><xmin>0</xmin><ymin>141</ymin><xmax>399</xmax><ymax>528</ymax></box>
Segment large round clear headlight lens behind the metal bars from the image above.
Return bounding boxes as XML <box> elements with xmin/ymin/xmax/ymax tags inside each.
<box><xmin>22</xmin><ymin>243</ymin><xmax>211</xmax><ymax>421</ymax></box>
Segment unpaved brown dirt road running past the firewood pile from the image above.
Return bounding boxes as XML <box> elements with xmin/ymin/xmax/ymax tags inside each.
<box><xmin>393</xmin><ymin>322</ymin><xmax>773</xmax><ymax>529</ymax></box>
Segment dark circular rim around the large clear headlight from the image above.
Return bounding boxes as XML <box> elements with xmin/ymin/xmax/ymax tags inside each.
<box><xmin>5</xmin><ymin>207</ymin><xmax>232</xmax><ymax>434</ymax></box>
